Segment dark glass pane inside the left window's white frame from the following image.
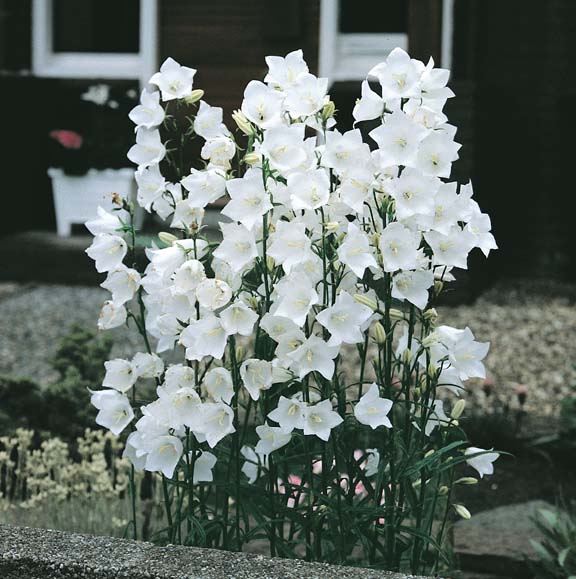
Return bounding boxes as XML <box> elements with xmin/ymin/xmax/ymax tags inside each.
<box><xmin>53</xmin><ymin>0</ymin><xmax>140</xmax><ymax>53</ymax></box>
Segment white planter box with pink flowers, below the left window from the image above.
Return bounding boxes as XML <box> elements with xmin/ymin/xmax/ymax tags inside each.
<box><xmin>48</xmin><ymin>169</ymin><xmax>144</xmax><ymax>237</ymax></box>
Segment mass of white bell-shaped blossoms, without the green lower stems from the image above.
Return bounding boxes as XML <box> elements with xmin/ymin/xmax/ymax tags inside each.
<box><xmin>87</xmin><ymin>49</ymin><xmax>496</xmax><ymax>480</ymax></box>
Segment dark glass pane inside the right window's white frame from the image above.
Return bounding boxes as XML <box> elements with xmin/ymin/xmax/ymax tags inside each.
<box><xmin>339</xmin><ymin>0</ymin><xmax>408</xmax><ymax>34</ymax></box>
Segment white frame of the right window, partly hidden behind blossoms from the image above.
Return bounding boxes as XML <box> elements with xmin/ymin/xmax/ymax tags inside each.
<box><xmin>318</xmin><ymin>0</ymin><xmax>454</xmax><ymax>83</ymax></box>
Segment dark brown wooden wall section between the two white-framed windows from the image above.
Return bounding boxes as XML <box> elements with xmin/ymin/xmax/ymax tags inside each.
<box><xmin>159</xmin><ymin>0</ymin><xmax>320</xmax><ymax>113</ymax></box>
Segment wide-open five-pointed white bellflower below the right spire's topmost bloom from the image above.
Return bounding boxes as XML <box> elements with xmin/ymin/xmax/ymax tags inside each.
<box><xmin>369</xmin><ymin>111</ymin><xmax>430</xmax><ymax>166</ymax></box>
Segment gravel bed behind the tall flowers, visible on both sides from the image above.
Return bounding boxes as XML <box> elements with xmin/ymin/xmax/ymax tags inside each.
<box><xmin>0</xmin><ymin>283</ymin><xmax>576</xmax><ymax>416</ymax></box>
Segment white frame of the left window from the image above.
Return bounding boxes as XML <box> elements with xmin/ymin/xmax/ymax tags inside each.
<box><xmin>32</xmin><ymin>0</ymin><xmax>158</xmax><ymax>86</ymax></box>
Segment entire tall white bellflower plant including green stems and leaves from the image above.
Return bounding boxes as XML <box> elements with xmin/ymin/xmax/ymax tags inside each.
<box><xmin>86</xmin><ymin>49</ymin><xmax>498</xmax><ymax>573</ymax></box>
